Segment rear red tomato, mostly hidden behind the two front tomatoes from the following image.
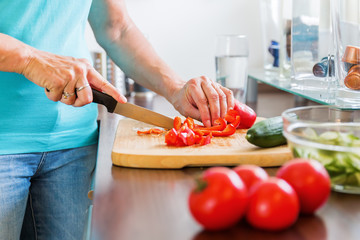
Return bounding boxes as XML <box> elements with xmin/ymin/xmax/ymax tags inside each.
<box><xmin>233</xmin><ymin>165</ymin><xmax>269</xmax><ymax>190</ymax></box>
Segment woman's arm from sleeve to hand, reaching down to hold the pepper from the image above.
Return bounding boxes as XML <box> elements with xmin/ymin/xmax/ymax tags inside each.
<box><xmin>89</xmin><ymin>0</ymin><xmax>234</xmax><ymax>126</ymax></box>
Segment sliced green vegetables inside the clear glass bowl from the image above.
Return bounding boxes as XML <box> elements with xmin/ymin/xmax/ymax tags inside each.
<box><xmin>291</xmin><ymin>128</ymin><xmax>360</xmax><ymax>187</ymax></box>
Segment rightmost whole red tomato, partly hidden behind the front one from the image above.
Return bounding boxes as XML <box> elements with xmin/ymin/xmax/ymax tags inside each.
<box><xmin>276</xmin><ymin>158</ymin><xmax>331</xmax><ymax>214</ymax></box>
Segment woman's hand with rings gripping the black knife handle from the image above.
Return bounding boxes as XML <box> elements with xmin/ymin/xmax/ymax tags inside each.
<box><xmin>22</xmin><ymin>48</ymin><xmax>126</xmax><ymax>107</ymax></box>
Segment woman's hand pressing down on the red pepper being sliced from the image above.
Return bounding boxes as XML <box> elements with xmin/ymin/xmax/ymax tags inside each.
<box><xmin>171</xmin><ymin>76</ymin><xmax>234</xmax><ymax>127</ymax></box>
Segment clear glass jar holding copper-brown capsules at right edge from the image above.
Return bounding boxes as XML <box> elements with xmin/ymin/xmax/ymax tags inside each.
<box><xmin>331</xmin><ymin>0</ymin><xmax>360</xmax><ymax>109</ymax></box>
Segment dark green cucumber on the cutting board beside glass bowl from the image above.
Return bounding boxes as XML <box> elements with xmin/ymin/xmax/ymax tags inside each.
<box><xmin>245</xmin><ymin>116</ymin><xmax>286</xmax><ymax>148</ymax></box>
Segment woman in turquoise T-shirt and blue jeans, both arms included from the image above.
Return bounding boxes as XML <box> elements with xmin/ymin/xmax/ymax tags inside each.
<box><xmin>0</xmin><ymin>0</ymin><xmax>234</xmax><ymax>240</ymax></box>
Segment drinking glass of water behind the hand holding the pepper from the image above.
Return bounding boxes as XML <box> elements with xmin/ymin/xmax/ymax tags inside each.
<box><xmin>215</xmin><ymin>35</ymin><xmax>249</xmax><ymax>103</ymax></box>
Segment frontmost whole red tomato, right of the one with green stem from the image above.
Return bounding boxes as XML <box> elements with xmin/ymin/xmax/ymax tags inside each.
<box><xmin>246</xmin><ymin>177</ymin><xmax>299</xmax><ymax>231</ymax></box>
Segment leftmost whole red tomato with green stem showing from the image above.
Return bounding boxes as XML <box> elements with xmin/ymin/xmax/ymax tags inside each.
<box><xmin>189</xmin><ymin>167</ymin><xmax>248</xmax><ymax>230</ymax></box>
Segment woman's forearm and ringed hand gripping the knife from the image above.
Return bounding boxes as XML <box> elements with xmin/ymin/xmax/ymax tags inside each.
<box><xmin>0</xmin><ymin>33</ymin><xmax>126</xmax><ymax>106</ymax></box>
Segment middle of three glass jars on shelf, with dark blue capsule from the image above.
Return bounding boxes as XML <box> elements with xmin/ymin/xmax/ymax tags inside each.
<box><xmin>291</xmin><ymin>0</ymin><xmax>336</xmax><ymax>100</ymax></box>
